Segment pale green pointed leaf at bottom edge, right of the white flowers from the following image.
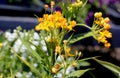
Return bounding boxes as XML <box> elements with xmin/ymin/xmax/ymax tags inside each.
<box><xmin>67</xmin><ymin>68</ymin><xmax>92</xmax><ymax>78</ymax></box>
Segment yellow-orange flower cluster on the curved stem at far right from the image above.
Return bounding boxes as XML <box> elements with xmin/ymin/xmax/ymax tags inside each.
<box><xmin>92</xmin><ymin>12</ymin><xmax>112</xmax><ymax>48</ymax></box>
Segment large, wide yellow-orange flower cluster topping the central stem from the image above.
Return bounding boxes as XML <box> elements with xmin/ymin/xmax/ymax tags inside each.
<box><xmin>35</xmin><ymin>11</ymin><xmax>76</xmax><ymax>31</ymax></box>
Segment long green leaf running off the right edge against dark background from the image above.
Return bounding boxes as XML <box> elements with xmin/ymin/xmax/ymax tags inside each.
<box><xmin>94</xmin><ymin>58</ymin><xmax>120</xmax><ymax>77</ymax></box>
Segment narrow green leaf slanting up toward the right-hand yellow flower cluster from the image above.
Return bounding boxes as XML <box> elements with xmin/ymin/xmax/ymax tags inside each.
<box><xmin>69</xmin><ymin>32</ymin><xmax>92</xmax><ymax>44</ymax></box>
